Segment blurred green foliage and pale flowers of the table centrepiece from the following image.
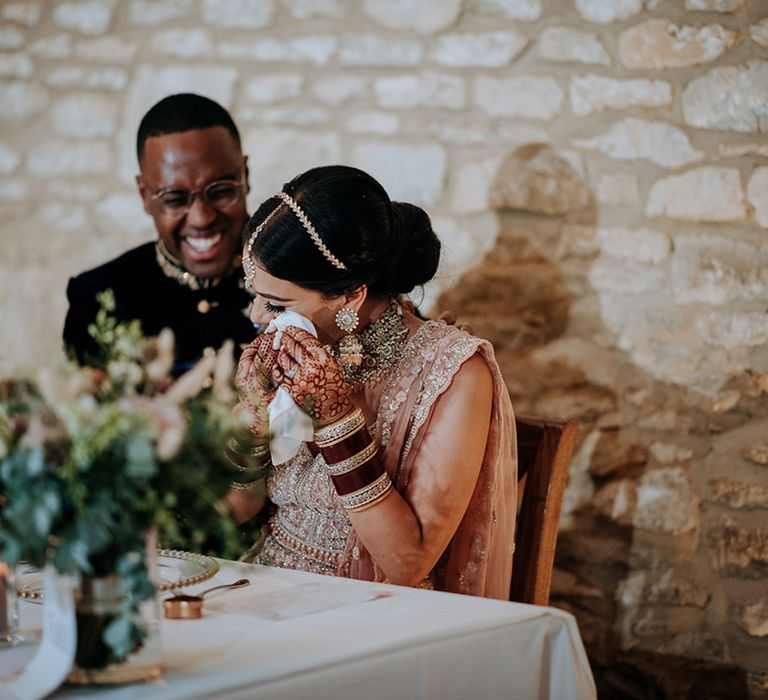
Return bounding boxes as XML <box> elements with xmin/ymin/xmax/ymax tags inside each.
<box><xmin>0</xmin><ymin>292</ymin><xmax>266</xmax><ymax>668</ymax></box>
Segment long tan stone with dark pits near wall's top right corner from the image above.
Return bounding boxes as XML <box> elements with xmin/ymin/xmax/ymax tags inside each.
<box><xmin>619</xmin><ymin>19</ymin><xmax>739</xmax><ymax>70</ymax></box>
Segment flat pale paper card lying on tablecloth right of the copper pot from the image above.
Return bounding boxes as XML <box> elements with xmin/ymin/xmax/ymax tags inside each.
<box><xmin>205</xmin><ymin>581</ymin><xmax>392</xmax><ymax>620</ymax></box>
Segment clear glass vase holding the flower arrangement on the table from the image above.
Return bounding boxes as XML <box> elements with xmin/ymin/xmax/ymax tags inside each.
<box><xmin>67</xmin><ymin>538</ymin><xmax>162</xmax><ymax>685</ymax></box>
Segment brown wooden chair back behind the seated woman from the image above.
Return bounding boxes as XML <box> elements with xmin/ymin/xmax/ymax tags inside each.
<box><xmin>509</xmin><ymin>416</ymin><xmax>578</xmax><ymax>605</ymax></box>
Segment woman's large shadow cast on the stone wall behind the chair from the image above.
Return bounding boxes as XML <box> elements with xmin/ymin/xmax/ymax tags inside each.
<box><xmin>437</xmin><ymin>144</ymin><xmax>747</xmax><ymax>698</ymax></box>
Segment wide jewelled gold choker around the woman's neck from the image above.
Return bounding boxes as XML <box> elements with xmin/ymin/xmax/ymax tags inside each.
<box><xmin>326</xmin><ymin>299</ymin><xmax>408</xmax><ymax>391</ymax></box>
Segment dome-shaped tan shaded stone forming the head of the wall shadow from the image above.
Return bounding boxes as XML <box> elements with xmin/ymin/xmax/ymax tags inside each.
<box><xmin>491</xmin><ymin>143</ymin><xmax>592</xmax><ymax>216</ymax></box>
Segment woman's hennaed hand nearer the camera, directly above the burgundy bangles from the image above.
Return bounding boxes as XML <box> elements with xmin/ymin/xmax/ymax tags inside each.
<box><xmin>272</xmin><ymin>326</ymin><xmax>352</xmax><ymax>425</ymax></box>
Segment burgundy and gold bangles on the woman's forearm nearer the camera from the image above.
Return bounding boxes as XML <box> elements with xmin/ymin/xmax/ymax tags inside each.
<box><xmin>315</xmin><ymin>408</ymin><xmax>392</xmax><ymax>512</ymax></box>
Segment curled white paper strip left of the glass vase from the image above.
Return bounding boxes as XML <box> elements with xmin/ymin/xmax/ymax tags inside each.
<box><xmin>0</xmin><ymin>566</ymin><xmax>77</xmax><ymax>700</ymax></box>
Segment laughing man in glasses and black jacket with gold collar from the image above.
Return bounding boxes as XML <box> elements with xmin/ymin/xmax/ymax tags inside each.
<box><xmin>64</xmin><ymin>93</ymin><xmax>255</xmax><ymax>375</ymax></box>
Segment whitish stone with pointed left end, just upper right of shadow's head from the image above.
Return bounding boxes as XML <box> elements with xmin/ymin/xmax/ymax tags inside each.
<box><xmin>573</xmin><ymin>117</ymin><xmax>704</xmax><ymax>168</ymax></box>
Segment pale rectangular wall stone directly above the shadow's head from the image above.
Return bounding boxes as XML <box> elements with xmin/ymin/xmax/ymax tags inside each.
<box><xmin>473</xmin><ymin>75</ymin><xmax>563</xmax><ymax>121</ymax></box>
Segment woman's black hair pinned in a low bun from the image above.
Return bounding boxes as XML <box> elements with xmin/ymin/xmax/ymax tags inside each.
<box><xmin>244</xmin><ymin>165</ymin><xmax>440</xmax><ymax>297</ymax></box>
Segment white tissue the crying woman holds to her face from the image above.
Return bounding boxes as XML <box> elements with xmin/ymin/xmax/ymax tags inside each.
<box><xmin>264</xmin><ymin>310</ymin><xmax>317</xmax><ymax>464</ymax></box>
